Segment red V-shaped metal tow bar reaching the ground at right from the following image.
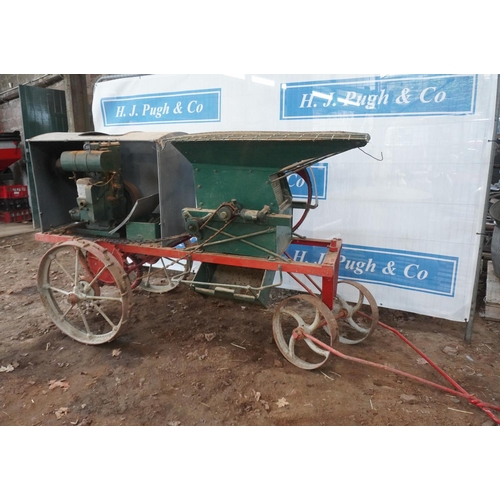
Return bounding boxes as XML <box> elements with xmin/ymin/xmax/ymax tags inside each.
<box><xmin>292</xmin><ymin>312</ymin><xmax>500</xmax><ymax>425</ymax></box>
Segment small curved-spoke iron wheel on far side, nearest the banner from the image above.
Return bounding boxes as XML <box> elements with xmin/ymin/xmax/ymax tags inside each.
<box><xmin>333</xmin><ymin>281</ymin><xmax>379</xmax><ymax>344</ymax></box>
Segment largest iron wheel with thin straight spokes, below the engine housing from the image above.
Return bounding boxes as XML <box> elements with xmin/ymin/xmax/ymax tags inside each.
<box><xmin>38</xmin><ymin>240</ymin><xmax>131</xmax><ymax>345</ymax></box>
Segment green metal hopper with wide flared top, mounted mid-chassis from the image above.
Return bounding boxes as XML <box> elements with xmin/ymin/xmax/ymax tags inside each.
<box><xmin>169</xmin><ymin>132</ymin><xmax>370</xmax><ymax>304</ymax></box>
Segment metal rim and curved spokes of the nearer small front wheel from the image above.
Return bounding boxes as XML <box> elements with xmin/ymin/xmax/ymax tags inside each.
<box><xmin>273</xmin><ymin>295</ymin><xmax>338</xmax><ymax>370</ymax></box>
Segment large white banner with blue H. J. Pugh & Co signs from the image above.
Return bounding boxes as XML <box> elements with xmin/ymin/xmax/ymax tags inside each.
<box><xmin>93</xmin><ymin>75</ymin><xmax>498</xmax><ymax>321</ymax></box>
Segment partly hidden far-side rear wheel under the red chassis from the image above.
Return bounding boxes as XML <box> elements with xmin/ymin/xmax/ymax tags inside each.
<box><xmin>139</xmin><ymin>257</ymin><xmax>191</xmax><ymax>293</ymax></box>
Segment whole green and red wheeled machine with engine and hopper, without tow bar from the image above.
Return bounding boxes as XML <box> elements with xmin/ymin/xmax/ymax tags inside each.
<box><xmin>30</xmin><ymin>132</ymin><xmax>378</xmax><ymax>369</ymax></box>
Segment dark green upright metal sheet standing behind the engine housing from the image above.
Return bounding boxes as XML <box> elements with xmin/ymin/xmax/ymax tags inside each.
<box><xmin>19</xmin><ymin>85</ymin><xmax>68</xmax><ymax>228</ymax></box>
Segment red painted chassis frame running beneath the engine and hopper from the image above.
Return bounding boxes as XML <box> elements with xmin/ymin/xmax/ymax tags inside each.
<box><xmin>35</xmin><ymin>233</ymin><xmax>342</xmax><ymax>310</ymax></box>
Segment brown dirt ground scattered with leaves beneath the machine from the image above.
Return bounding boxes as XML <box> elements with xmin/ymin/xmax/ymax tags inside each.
<box><xmin>0</xmin><ymin>229</ymin><xmax>500</xmax><ymax>426</ymax></box>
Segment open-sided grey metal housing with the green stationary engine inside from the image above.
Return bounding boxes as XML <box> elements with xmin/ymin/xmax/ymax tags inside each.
<box><xmin>29</xmin><ymin>132</ymin><xmax>195</xmax><ymax>246</ymax></box>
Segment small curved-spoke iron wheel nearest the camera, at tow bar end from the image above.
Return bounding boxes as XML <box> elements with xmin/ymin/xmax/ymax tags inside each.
<box><xmin>273</xmin><ymin>295</ymin><xmax>338</xmax><ymax>370</ymax></box>
